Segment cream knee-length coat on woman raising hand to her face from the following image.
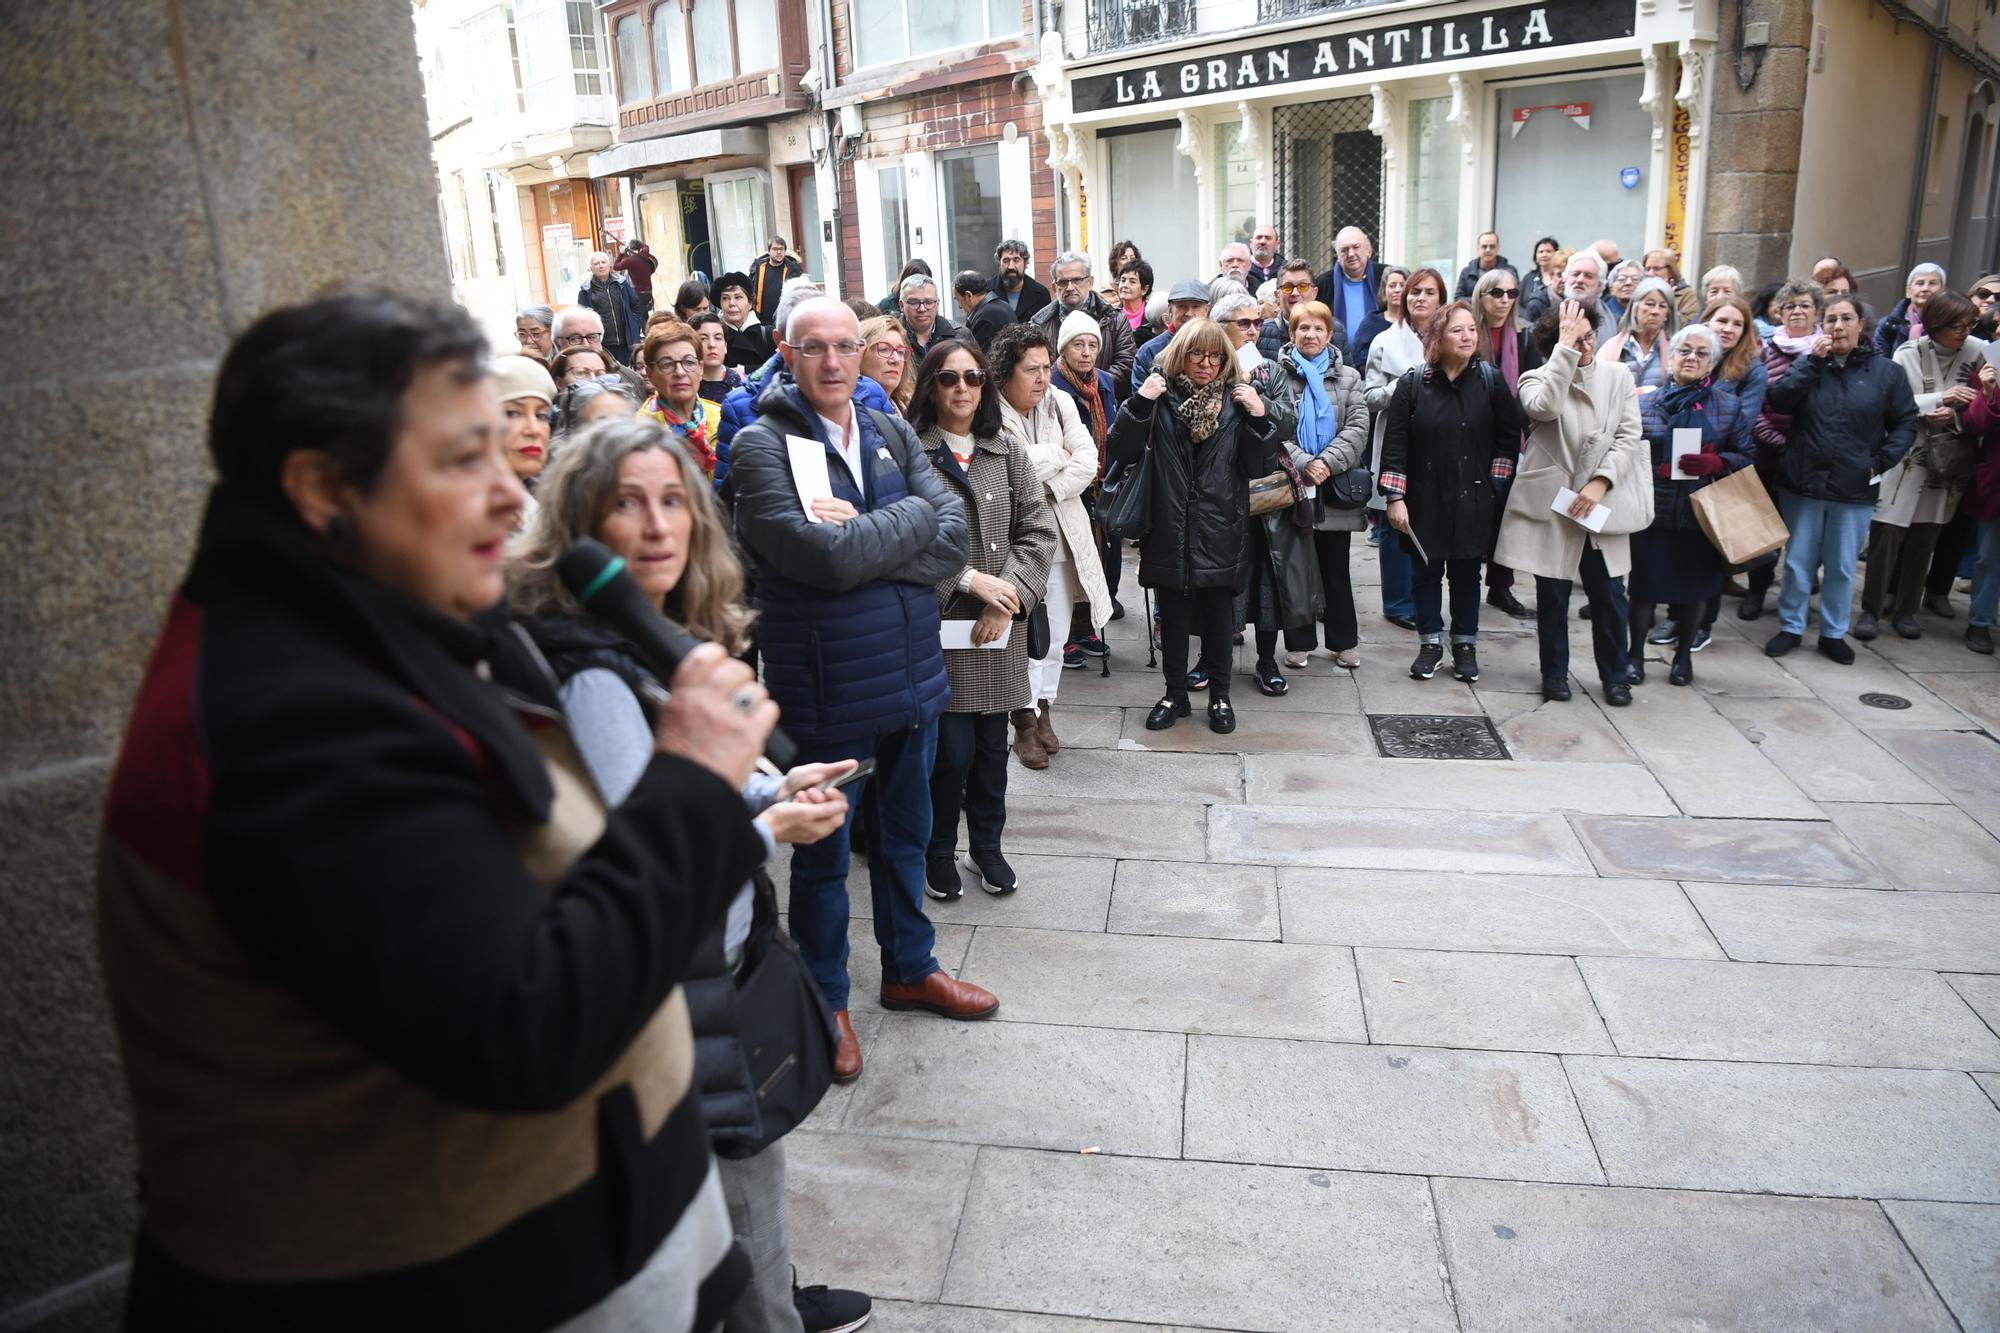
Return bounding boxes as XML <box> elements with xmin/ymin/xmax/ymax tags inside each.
<box><xmin>1494</xmin><ymin>344</ymin><xmax>1650</xmax><ymax>580</ymax></box>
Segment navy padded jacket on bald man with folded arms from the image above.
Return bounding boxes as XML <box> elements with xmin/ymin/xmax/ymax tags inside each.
<box><xmin>732</xmin><ymin>376</ymin><xmax>970</xmax><ymax>747</ymax></box>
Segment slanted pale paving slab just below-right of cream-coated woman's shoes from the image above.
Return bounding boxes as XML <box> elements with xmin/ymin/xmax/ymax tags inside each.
<box><xmin>1608</xmin><ymin>688</ymin><xmax>1820</xmax><ymax>819</ymax></box>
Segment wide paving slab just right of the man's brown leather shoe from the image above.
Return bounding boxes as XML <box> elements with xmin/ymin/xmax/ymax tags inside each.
<box><xmin>948</xmin><ymin>927</ymin><xmax>1368</xmax><ymax>1041</ymax></box>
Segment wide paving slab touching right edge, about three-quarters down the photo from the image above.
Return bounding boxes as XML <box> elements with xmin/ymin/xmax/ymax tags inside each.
<box><xmin>1568</xmin><ymin>959</ymin><xmax>2000</xmax><ymax>1069</ymax></box>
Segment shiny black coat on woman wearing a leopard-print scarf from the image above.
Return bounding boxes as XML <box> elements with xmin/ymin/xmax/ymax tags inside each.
<box><xmin>1106</xmin><ymin>388</ymin><xmax>1278</xmax><ymax>592</ymax></box>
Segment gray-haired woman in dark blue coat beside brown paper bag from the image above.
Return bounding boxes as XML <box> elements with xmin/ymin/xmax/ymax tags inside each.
<box><xmin>1628</xmin><ymin>316</ymin><xmax>1754</xmax><ymax>685</ymax></box>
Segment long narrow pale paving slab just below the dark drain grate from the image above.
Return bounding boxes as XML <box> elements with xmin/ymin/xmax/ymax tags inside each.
<box><xmin>1244</xmin><ymin>755</ymin><xmax>1680</xmax><ymax>815</ymax></box>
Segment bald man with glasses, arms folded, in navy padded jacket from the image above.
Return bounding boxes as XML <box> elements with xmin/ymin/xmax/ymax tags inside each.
<box><xmin>732</xmin><ymin>296</ymin><xmax>1000</xmax><ymax>1081</ymax></box>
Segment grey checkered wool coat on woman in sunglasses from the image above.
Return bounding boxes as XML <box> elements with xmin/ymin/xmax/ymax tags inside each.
<box><xmin>918</xmin><ymin>426</ymin><xmax>1056</xmax><ymax>713</ymax></box>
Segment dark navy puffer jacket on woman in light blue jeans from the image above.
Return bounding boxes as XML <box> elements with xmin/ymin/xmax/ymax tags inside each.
<box><xmin>1764</xmin><ymin>344</ymin><xmax>1916</xmax><ymax>504</ymax></box>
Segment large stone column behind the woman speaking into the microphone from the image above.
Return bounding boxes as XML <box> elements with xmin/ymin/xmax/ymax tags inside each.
<box><xmin>0</xmin><ymin>0</ymin><xmax>450</xmax><ymax>1329</ymax></box>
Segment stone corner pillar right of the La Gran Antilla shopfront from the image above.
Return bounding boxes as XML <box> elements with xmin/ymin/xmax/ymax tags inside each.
<box><xmin>1686</xmin><ymin>0</ymin><xmax>1812</xmax><ymax>286</ymax></box>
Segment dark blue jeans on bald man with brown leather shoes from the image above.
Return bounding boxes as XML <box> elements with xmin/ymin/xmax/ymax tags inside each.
<box><xmin>790</xmin><ymin>723</ymin><xmax>938</xmax><ymax>1009</ymax></box>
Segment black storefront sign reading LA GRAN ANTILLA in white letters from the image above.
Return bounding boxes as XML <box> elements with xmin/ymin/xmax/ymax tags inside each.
<box><xmin>1070</xmin><ymin>0</ymin><xmax>1632</xmax><ymax>113</ymax></box>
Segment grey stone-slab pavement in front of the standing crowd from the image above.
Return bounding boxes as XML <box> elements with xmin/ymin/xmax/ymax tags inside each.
<box><xmin>772</xmin><ymin>542</ymin><xmax>2000</xmax><ymax>1333</ymax></box>
